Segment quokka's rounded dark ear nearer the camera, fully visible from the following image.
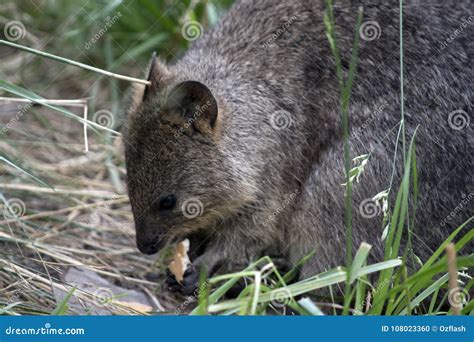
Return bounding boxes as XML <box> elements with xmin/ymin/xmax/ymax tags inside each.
<box><xmin>164</xmin><ymin>81</ymin><xmax>218</xmax><ymax>133</ymax></box>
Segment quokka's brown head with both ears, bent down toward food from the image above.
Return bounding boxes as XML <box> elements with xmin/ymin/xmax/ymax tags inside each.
<box><xmin>124</xmin><ymin>57</ymin><xmax>254</xmax><ymax>254</ymax></box>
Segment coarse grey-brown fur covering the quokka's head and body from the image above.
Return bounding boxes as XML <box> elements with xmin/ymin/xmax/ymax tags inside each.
<box><xmin>125</xmin><ymin>0</ymin><xmax>474</xmax><ymax>277</ymax></box>
